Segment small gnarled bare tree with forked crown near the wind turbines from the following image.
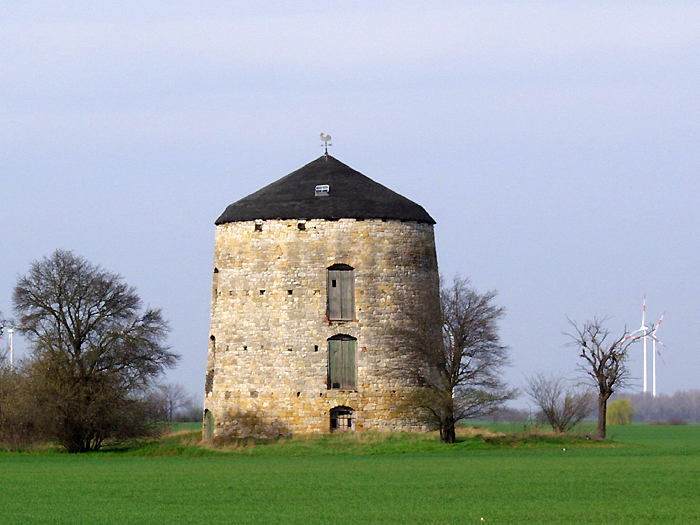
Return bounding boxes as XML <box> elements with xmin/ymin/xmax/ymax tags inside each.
<box><xmin>566</xmin><ymin>317</ymin><xmax>638</xmax><ymax>439</ymax></box>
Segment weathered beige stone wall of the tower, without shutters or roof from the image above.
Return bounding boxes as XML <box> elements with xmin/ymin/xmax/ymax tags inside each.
<box><xmin>205</xmin><ymin>215</ymin><xmax>438</xmax><ymax>436</ymax></box>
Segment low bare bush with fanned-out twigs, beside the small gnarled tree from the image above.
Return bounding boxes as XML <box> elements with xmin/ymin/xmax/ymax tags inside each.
<box><xmin>525</xmin><ymin>372</ymin><xmax>595</xmax><ymax>432</ymax></box>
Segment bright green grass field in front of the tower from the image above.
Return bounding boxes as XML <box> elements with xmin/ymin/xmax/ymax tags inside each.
<box><xmin>0</xmin><ymin>425</ymin><xmax>700</xmax><ymax>525</ymax></box>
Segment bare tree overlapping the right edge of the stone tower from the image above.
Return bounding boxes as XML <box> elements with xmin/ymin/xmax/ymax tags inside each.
<box><xmin>401</xmin><ymin>276</ymin><xmax>515</xmax><ymax>443</ymax></box>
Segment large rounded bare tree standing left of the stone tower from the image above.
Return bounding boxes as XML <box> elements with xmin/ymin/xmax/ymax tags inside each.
<box><xmin>13</xmin><ymin>250</ymin><xmax>178</xmax><ymax>452</ymax></box>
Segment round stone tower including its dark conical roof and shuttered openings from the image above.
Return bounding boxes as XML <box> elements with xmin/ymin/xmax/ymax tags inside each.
<box><xmin>204</xmin><ymin>155</ymin><xmax>438</xmax><ymax>437</ymax></box>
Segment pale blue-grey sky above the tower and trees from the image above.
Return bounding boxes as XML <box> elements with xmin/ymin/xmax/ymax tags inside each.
<box><xmin>0</xmin><ymin>0</ymin><xmax>700</xmax><ymax>406</ymax></box>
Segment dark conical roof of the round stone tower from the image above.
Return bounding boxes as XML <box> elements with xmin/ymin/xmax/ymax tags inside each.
<box><xmin>216</xmin><ymin>155</ymin><xmax>435</xmax><ymax>224</ymax></box>
